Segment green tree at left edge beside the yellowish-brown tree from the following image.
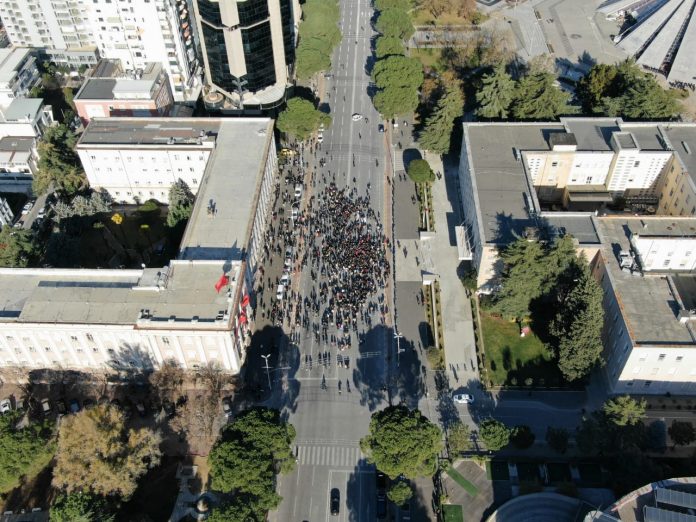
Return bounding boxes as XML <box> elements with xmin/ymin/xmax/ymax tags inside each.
<box><xmin>0</xmin><ymin>413</ymin><xmax>55</xmax><ymax>493</ymax></box>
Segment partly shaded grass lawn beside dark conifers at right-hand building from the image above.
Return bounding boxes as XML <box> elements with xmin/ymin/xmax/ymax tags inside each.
<box><xmin>481</xmin><ymin>310</ymin><xmax>564</xmax><ymax>386</ymax></box>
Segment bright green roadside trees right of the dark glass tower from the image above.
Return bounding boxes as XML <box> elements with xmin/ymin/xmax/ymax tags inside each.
<box><xmin>295</xmin><ymin>0</ymin><xmax>341</xmax><ymax>80</ymax></box>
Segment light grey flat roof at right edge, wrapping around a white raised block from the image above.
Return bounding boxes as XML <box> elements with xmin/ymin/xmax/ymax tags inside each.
<box><xmin>595</xmin><ymin>216</ymin><xmax>696</xmax><ymax>345</ymax></box>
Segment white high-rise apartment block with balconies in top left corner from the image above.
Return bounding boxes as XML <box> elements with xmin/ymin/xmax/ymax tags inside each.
<box><xmin>0</xmin><ymin>0</ymin><xmax>201</xmax><ymax>103</ymax></box>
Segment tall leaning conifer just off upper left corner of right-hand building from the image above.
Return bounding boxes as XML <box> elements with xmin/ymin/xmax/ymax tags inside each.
<box><xmin>419</xmin><ymin>82</ymin><xmax>464</xmax><ymax>154</ymax></box>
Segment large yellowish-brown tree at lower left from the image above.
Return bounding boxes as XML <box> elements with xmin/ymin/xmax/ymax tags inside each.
<box><xmin>53</xmin><ymin>405</ymin><xmax>161</xmax><ymax>499</ymax></box>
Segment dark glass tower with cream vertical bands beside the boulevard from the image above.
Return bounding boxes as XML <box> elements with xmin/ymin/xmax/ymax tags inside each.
<box><xmin>193</xmin><ymin>0</ymin><xmax>300</xmax><ymax>109</ymax></box>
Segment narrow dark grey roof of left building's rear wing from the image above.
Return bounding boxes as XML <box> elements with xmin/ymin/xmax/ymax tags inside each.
<box><xmin>77</xmin><ymin>118</ymin><xmax>219</xmax><ymax>149</ymax></box>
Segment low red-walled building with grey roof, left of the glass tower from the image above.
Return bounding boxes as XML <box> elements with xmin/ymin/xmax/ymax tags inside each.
<box><xmin>73</xmin><ymin>60</ymin><xmax>174</xmax><ymax>125</ymax></box>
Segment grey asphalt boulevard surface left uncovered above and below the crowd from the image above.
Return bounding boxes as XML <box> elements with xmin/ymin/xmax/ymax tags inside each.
<box><xmin>270</xmin><ymin>0</ymin><xmax>388</xmax><ymax>522</ymax></box>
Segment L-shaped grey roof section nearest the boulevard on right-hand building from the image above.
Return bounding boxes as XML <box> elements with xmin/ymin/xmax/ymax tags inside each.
<box><xmin>464</xmin><ymin>123</ymin><xmax>565</xmax><ymax>244</ymax></box>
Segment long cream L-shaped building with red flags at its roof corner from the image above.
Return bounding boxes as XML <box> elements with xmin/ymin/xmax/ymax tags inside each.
<box><xmin>0</xmin><ymin>118</ymin><xmax>277</xmax><ymax>373</ymax></box>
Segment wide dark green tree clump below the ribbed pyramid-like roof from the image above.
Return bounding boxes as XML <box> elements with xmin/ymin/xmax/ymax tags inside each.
<box><xmin>576</xmin><ymin>59</ymin><xmax>681</xmax><ymax>120</ymax></box>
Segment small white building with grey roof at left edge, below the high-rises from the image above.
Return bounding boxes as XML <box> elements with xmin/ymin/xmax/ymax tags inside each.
<box><xmin>0</xmin><ymin>47</ymin><xmax>40</xmax><ymax>108</ymax></box>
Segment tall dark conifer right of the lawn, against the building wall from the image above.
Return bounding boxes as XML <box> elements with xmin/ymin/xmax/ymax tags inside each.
<box><xmin>550</xmin><ymin>256</ymin><xmax>604</xmax><ymax>381</ymax></box>
